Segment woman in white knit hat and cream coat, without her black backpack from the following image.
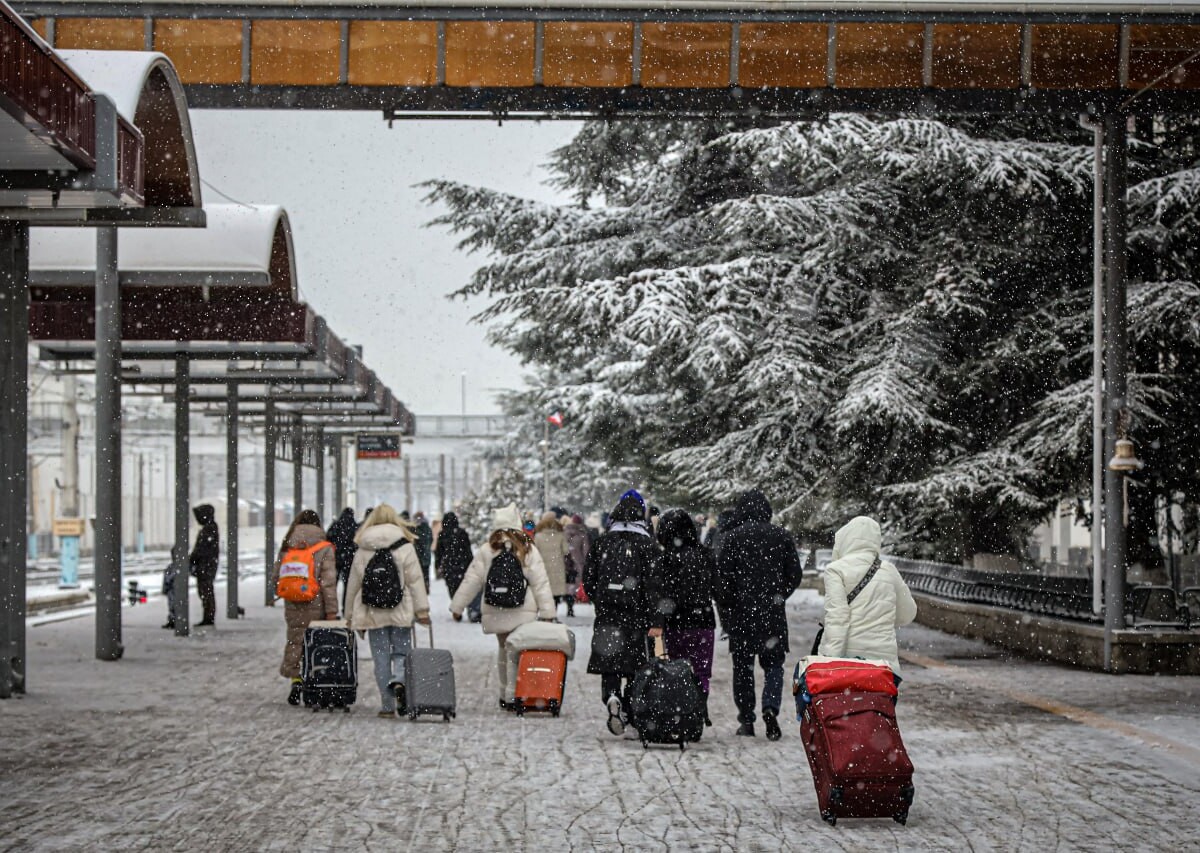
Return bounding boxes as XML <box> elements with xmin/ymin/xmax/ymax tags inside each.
<box><xmin>450</xmin><ymin>504</ymin><xmax>557</xmax><ymax>710</ymax></box>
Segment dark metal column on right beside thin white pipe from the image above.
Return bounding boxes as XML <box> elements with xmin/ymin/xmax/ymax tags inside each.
<box><xmin>1102</xmin><ymin>115</ymin><xmax>1128</xmax><ymax>672</ymax></box>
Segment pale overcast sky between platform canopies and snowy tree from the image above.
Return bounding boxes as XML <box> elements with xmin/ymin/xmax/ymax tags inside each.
<box><xmin>192</xmin><ymin>109</ymin><xmax>578</xmax><ymax>415</ymax></box>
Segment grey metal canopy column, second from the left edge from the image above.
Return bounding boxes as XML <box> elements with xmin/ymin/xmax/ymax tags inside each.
<box><xmin>95</xmin><ymin>228</ymin><xmax>123</xmax><ymax>661</ymax></box>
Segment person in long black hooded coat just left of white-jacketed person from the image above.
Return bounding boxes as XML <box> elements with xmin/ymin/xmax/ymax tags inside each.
<box><xmin>716</xmin><ymin>489</ymin><xmax>800</xmax><ymax>740</ymax></box>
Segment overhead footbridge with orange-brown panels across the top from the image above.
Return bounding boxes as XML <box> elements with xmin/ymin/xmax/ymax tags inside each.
<box><xmin>24</xmin><ymin>9</ymin><xmax>1200</xmax><ymax>118</ymax></box>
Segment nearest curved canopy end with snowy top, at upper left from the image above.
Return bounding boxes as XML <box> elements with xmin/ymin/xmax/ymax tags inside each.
<box><xmin>59</xmin><ymin>50</ymin><xmax>203</xmax><ymax>208</ymax></box>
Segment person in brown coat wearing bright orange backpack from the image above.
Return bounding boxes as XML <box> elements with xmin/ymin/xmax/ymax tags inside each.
<box><xmin>269</xmin><ymin>510</ymin><xmax>337</xmax><ymax>705</ymax></box>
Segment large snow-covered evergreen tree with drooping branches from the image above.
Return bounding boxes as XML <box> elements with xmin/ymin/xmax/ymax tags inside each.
<box><xmin>428</xmin><ymin>115</ymin><xmax>1196</xmax><ymax>558</ymax></box>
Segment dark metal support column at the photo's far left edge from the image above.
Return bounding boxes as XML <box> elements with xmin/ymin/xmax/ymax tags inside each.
<box><xmin>0</xmin><ymin>222</ymin><xmax>29</xmax><ymax>698</ymax></box>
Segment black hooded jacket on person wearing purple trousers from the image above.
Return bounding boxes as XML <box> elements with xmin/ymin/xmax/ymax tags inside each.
<box><xmin>652</xmin><ymin>510</ymin><xmax>716</xmax><ymax>631</ymax></box>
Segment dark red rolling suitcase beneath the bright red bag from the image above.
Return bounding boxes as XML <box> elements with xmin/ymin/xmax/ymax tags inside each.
<box><xmin>800</xmin><ymin>692</ymin><xmax>913</xmax><ymax>825</ymax></box>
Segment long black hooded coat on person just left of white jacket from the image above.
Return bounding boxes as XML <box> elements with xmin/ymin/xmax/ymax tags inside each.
<box><xmin>716</xmin><ymin>489</ymin><xmax>802</xmax><ymax>653</ymax></box>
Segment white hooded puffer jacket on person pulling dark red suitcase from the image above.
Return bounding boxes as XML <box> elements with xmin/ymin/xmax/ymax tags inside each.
<box><xmin>820</xmin><ymin>516</ymin><xmax>917</xmax><ymax>673</ymax></box>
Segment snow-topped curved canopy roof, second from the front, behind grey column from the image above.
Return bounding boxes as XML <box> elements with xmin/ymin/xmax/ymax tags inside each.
<box><xmin>29</xmin><ymin>204</ymin><xmax>296</xmax><ymax>293</ymax></box>
